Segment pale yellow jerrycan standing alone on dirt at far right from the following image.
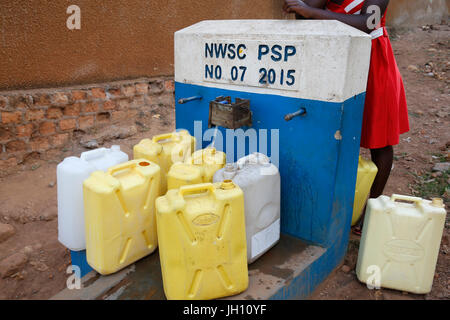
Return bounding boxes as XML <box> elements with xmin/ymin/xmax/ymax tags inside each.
<box><xmin>356</xmin><ymin>194</ymin><xmax>446</xmax><ymax>294</ymax></box>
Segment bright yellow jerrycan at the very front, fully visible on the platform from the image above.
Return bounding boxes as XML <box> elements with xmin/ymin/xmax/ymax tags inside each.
<box><xmin>156</xmin><ymin>180</ymin><xmax>248</xmax><ymax>300</ymax></box>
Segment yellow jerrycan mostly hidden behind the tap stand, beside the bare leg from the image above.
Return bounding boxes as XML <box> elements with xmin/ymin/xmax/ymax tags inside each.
<box><xmin>352</xmin><ymin>156</ymin><xmax>378</xmax><ymax>226</ymax></box>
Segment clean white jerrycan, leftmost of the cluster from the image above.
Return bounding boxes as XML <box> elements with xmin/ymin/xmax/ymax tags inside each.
<box><xmin>56</xmin><ymin>145</ymin><xmax>128</xmax><ymax>251</ymax></box>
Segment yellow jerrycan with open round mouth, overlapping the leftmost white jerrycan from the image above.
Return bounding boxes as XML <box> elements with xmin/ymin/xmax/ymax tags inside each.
<box><xmin>83</xmin><ymin>159</ymin><xmax>160</xmax><ymax>275</ymax></box>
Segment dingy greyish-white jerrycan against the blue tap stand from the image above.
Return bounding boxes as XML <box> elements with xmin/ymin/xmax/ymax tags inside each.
<box><xmin>213</xmin><ymin>152</ymin><xmax>281</xmax><ymax>263</ymax></box>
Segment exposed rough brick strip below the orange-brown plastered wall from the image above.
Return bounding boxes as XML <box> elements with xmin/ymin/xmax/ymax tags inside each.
<box><xmin>0</xmin><ymin>78</ymin><xmax>174</xmax><ymax>173</ymax></box>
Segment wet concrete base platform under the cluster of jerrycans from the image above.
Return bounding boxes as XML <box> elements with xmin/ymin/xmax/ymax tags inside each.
<box><xmin>52</xmin><ymin>235</ymin><xmax>336</xmax><ymax>300</ymax></box>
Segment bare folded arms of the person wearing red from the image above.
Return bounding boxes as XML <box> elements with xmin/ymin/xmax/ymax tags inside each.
<box><xmin>283</xmin><ymin>0</ymin><xmax>389</xmax><ymax>33</ymax></box>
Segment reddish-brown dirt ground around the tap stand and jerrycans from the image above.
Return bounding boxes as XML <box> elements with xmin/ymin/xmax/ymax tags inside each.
<box><xmin>0</xmin><ymin>25</ymin><xmax>450</xmax><ymax>300</ymax></box>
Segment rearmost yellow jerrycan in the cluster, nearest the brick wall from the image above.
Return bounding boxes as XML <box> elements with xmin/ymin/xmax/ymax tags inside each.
<box><xmin>133</xmin><ymin>130</ymin><xmax>195</xmax><ymax>195</ymax></box>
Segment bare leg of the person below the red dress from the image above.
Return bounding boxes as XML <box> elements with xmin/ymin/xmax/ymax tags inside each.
<box><xmin>354</xmin><ymin>146</ymin><xmax>394</xmax><ymax>234</ymax></box>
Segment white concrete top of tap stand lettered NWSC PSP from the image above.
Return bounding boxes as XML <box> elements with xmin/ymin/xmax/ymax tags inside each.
<box><xmin>175</xmin><ymin>20</ymin><xmax>371</xmax><ymax>102</ymax></box>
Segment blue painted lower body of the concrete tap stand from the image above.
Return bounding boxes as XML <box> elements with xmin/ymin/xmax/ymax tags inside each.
<box><xmin>175</xmin><ymin>82</ymin><xmax>365</xmax><ymax>299</ymax></box>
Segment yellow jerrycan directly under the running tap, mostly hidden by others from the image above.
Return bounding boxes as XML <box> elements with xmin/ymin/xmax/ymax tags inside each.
<box><xmin>167</xmin><ymin>148</ymin><xmax>227</xmax><ymax>190</ymax></box>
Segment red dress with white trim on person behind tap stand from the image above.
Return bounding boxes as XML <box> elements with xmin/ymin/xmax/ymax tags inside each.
<box><xmin>326</xmin><ymin>0</ymin><xmax>409</xmax><ymax>149</ymax></box>
